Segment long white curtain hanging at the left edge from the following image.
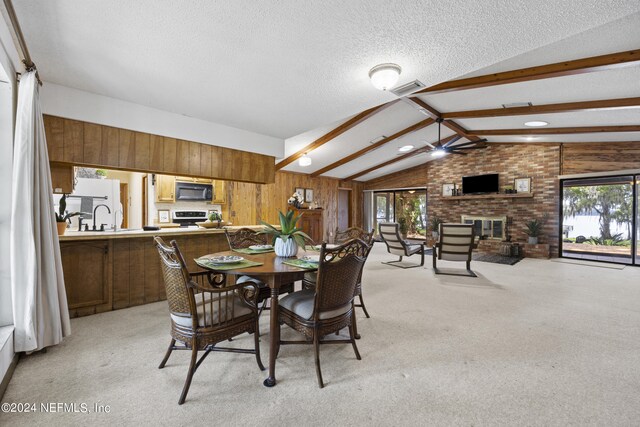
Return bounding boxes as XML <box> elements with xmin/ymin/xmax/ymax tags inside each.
<box><xmin>10</xmin><ymin>71</ymin><xmax>71</xmax><ymax>352</ymax></box>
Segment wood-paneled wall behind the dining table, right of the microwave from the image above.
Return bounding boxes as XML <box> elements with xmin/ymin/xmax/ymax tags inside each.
<box><xmin>222</xmin><ymin>172</ymin><xmax>364</xmax><ymax>239</ymax></box>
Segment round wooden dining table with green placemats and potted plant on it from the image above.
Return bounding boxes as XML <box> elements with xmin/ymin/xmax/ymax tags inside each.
<box><xmin>195</xmin><ymin>251</ymin><xmax>314</xmax><ymax>387</ymax></box>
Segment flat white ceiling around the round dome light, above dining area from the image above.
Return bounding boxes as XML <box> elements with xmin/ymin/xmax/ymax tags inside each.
<box><xmin>14</xmin><ymin>0</ymin><xmax>640</xmax><ymax>138</ymax></box>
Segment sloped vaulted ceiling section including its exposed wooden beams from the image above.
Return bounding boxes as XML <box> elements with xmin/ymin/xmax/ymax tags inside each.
<box><xmin>283</xmin><ymin>13</ymin><xmax>640</xmax><ymax>181</ymax></box>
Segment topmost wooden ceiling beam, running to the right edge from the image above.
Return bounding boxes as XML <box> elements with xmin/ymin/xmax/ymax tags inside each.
<box><xmin>416</xmin><ymin>49</ymin><xmax>640</xmax><ymax>94</ymax></box>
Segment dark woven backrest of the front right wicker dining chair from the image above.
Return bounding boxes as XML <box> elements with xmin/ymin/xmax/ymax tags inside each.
<box><xmin>313</xmin><ymin>239</ymin><xmax>372</xmax><ymax>320</ymax></box>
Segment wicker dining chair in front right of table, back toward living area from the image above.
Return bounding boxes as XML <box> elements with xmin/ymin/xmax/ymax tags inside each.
<box><xmin>276</xmin><ymin>239</ymin><xmax>371</xmax><ymax>388</ymax></box>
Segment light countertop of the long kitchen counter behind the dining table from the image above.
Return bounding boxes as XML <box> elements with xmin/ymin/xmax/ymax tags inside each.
<box><xmin>59</xmin><ymin>225</ymin><xmax>264</xmax><ymax>242</ymax></box>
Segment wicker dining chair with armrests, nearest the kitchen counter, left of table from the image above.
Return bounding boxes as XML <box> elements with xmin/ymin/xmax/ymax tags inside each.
<box><xmin>154</xmin><ymin>237</ymin><xmax>265</xmax><ymax>405</ymax></box>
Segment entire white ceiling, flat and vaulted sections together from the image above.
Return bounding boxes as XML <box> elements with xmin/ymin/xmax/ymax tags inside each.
<box><xmin>14</xmin><ymin>0</ymin><xmax>640</xmax><ymax>180</ymax></box>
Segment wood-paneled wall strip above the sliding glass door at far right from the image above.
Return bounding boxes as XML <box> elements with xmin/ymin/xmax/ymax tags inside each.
<box><xmin>561</xmin><ymin>142</ymin><xmax>640</xmax><ymax>175</ymax></box>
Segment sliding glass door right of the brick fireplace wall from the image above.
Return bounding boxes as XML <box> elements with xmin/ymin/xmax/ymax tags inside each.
<box><xmin>562</xmin><ymin>175</ymin><xmax>640</xmax><ymax>264</ymax></box>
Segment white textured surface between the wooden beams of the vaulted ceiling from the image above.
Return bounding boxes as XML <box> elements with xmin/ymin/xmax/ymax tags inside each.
<box><xmin>285</xmin><ymin>10</ymin><xmax>640</xmax><ymax>181</ymax></box>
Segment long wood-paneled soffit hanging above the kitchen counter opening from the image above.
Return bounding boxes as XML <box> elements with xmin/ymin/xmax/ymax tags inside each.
<box><xmin>44</xmin><ymin>115</ymin><xmax>275</xmax><ymax>184</ymax></box>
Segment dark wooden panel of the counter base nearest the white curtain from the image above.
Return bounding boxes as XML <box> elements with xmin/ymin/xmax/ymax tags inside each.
<box><xmin>60</xmin><ymin>240</ymin><xmax>113</xmax><ymax>317</ymax></box>
